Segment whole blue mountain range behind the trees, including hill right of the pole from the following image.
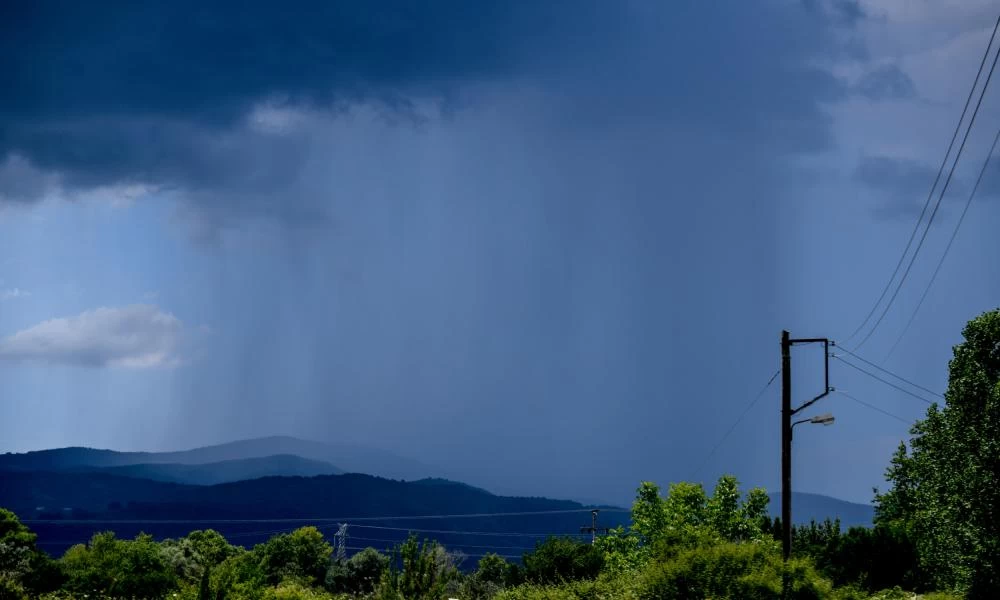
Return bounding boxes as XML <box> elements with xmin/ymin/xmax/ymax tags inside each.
<box><xmin>0</xmin><ymin>437</ymin><xmax>874</xmax><ymax>554</ymax></box>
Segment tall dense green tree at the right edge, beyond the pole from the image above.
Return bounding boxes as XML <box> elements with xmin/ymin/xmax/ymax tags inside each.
<box><xmin>876</xmin><ymin>309</ymin><xmax>1000</xmax><ymax>598</ymax></box>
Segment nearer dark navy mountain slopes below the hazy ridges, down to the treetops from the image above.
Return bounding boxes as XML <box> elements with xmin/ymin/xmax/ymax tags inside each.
<box><xmin>0</xmin><ymin>470</ymin><xmax>629</xmax><ymax>557</ymax></box>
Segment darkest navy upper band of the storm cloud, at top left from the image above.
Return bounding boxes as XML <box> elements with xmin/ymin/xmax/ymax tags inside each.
<box><xmin>0</xmin><ymin>0</ymin><xmax>610</xmax><ymax>123</ymax></box>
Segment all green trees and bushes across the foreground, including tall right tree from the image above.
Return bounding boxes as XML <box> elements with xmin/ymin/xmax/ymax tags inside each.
<box><xmin>0</xmin><ymin>310</ymin><xmax>1000</xmax><ymax>600</ymax></box>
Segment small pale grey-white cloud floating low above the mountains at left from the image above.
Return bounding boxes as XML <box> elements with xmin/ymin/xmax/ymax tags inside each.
<box><xmin>0</xmin><ymin>304</ymin><xmax>184</xmax><ymax>369</ymax></box>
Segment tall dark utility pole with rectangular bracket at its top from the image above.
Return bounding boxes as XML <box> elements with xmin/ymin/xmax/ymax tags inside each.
<box><xmin>781</xmin><ymin>331</ymin><xmax>833</xmax><ymax>561</ymax></box>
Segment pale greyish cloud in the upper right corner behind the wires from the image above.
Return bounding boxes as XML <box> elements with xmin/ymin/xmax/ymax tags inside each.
<box><xmin>830</xmin><ymin>0</ymin><xmax>1000</xmax><ymax>188</ymax></box>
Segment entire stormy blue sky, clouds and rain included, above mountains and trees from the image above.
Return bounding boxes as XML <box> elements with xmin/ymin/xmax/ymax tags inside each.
<box><xmin>0</xmin><ymin>0</ymin><xmax>1000</xmax><ymax>502</ymax></box>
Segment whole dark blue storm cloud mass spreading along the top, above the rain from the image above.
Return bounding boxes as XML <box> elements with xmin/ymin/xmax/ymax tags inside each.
<box><xmin>0</xmin><ymin>0</ymin><xmax>860</xmax><ymax>228</ymax></box>
